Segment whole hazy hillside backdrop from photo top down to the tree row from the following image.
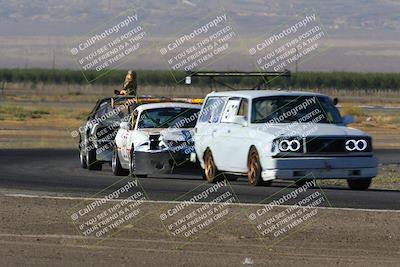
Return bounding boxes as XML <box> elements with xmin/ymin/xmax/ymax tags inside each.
<box><xmin>0</xmin><ymin>0</ymin><xmax>400</xmax><ymax>72</ymax></box>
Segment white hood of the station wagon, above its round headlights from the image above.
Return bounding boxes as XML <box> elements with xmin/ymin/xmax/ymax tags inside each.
<box><xmin>250</xmin><ymin>123</ymin><xmax>368</xmax><ymax>137</ymax></box>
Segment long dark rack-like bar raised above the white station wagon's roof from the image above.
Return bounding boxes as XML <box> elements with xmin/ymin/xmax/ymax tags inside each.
<box><xmin>185</xmin><ymin>70</ymin><xmax>291</xmax><ymax>90</ymax></box>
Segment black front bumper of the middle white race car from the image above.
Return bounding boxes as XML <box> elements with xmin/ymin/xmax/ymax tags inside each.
<box><xmin>134</xmin><ymin>151</ymin><xmax>200</xmax><ymax>175</ymax></box>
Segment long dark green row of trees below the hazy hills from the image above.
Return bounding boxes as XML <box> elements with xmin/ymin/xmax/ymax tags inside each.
<box><xmin>0</xmin><ymin>69</ymin><xmax>400</xmax><ymax>90</ymax></box>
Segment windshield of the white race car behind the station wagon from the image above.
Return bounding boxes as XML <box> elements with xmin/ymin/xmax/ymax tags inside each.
<box><xmin>138</xmin><ymin>107</ymin><xmax>200</xmax><ymax>129</ymax></box>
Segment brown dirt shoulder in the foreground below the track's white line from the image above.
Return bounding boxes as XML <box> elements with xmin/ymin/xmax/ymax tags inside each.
<box><xmin>0</xmin><ymin>196</ymin><xmax>400</xmax><ymax>266</ymax></box>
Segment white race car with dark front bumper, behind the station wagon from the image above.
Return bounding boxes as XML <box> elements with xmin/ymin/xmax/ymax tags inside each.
<box><xmin>111</xmin><ymin>102</ymin><xmax>201</xmax><ymax>176</ymax></box>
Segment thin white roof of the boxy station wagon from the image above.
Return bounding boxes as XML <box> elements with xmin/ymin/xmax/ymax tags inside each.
<box><xmin>208</xmin><ymin>90</ymin><xmax>326</xmax><ymax>99</ymax></box>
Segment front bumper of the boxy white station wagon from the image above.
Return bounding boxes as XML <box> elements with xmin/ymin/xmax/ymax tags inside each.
<box><xmin>261</xmin><ymin>156</ymin><xmax>378</xmax><ymax>181</ymax></box>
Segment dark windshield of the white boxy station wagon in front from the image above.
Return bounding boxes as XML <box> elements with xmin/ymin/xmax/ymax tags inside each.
<box><xmin>251</xmin><ymin>96</ymin><xmax>342</xmax><ymax>123</ymax></box>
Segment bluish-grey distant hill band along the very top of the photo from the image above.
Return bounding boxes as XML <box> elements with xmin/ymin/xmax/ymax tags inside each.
<box><xmin>0</xmin><ymin>0</ymin><xmax>400</xmax><ymax>38</ymax></box>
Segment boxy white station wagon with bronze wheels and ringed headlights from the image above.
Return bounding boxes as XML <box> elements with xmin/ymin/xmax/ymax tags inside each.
<box><xmin>194</xmin><ymin>90</ymin><xmax>378</xmax><ymax>189</ymax></box>
